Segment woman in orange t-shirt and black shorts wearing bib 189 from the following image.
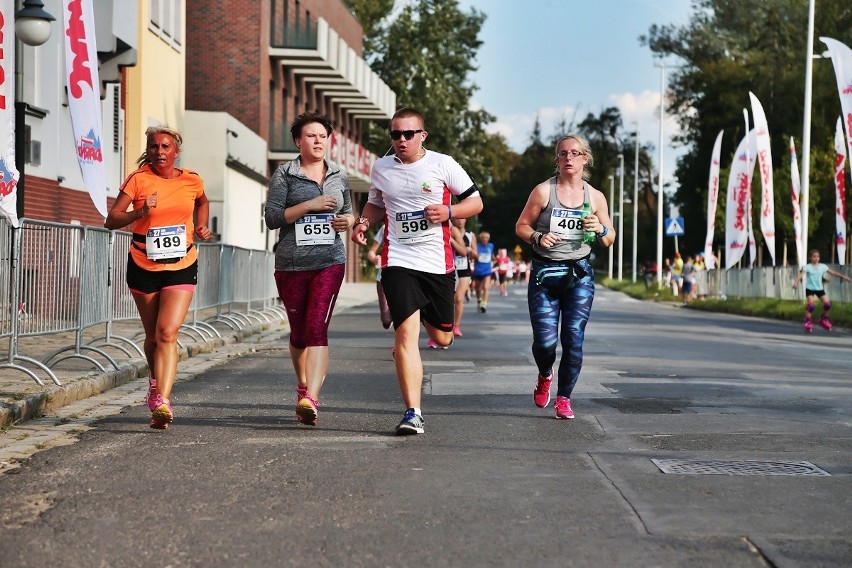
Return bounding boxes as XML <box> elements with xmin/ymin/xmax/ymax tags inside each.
<box><xmin>104</xmin><ymin>125</ymin><xmax>212</xmax><ymax>430</ymax></box>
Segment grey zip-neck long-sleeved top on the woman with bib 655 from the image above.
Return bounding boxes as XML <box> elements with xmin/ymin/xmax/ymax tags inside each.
<box><xmin>263</xmin><ymin>158</ymin><xmax>352</xmax><ymax>271</ymax></box>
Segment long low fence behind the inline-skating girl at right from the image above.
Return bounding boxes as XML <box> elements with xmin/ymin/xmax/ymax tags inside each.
<box><xmin>697</xmin><ymin>264</ymin><xmax>852</xmax><ymax>304</ymax></box>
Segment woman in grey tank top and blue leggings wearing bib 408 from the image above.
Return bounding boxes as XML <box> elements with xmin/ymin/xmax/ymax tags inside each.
<box><xmin>515</xmin><ymin>135</ymin><xmax>615</xmax><ymax>419</ymax></box>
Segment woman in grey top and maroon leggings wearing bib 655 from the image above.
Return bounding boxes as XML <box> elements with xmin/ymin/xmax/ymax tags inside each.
<box><xmin>264</xmin><ymin>113</ymin><xmax>355</xmax><ymax>426</ymax></box>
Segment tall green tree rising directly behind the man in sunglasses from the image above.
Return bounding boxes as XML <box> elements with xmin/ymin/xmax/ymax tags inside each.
<box><xmin>347</xmin><ymin>0</ymin><xmax>505</xmax><ymax>191</ymax></box>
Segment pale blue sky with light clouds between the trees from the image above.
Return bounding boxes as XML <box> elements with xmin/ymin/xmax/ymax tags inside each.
<box><xmin>459</xmin><ymin>0</ymin><xmax>691</xmax><ymax>181</ymax></box>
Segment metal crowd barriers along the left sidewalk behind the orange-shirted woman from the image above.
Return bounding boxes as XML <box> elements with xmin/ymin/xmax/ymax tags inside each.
<box><xmin>0</xmin><ymin>219</ymin><xmax>286</xmax><ymax>385</ymax></box>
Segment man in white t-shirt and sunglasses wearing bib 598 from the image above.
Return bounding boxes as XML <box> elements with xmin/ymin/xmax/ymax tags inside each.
<box><xmin>352</xmin><ymin>108</ymin><xmax>482</xmax><ymax>435</ymax></box>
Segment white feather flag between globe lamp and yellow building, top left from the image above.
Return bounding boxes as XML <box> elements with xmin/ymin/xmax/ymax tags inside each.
<box><xmin>62</xmin><ymin>0</ymin><xmax>107</xmax><ymax>217</ymax></box>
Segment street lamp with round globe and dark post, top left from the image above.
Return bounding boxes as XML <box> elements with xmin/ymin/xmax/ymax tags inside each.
<box><xmin>15</xmin><ymin>0</ymin><xmax>56</xmax><ymax>219</ymax></box>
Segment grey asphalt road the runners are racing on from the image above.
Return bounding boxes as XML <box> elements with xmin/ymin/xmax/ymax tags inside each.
<box><xmin>0</xmin><ymin>287</ymin><xmax>852</xmax><ymax>567</ymax></box>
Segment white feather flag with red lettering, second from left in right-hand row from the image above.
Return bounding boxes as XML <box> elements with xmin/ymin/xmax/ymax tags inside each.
<box><xmin>725</xmin><ymin>131</ymin><xmax>754</xmax><ymax>269</ymax></box>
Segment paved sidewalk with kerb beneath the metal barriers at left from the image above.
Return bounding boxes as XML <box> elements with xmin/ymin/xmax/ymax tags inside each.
<box><xmin>0</xmin><ymin>282</ymin><xmax>376</xmax><ymax>430</ymax></box>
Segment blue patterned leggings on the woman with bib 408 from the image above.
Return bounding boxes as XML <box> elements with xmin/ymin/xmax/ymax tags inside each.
<box><xmin>527</xmin><ymin>260</ymin><xmax>595</xmax><ymax>398</ymax></box>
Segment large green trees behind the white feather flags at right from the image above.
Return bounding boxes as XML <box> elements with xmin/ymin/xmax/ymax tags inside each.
<box><xmin>640</xmin><ymin>0</ymin><xmax>852</xmax><ymax>259</ymax></box>
